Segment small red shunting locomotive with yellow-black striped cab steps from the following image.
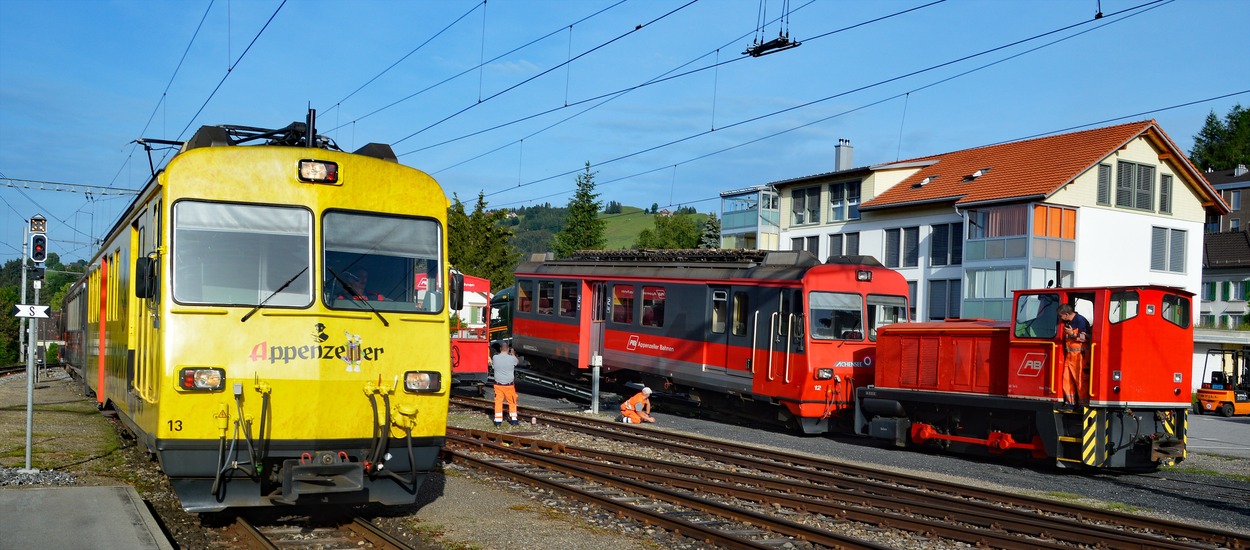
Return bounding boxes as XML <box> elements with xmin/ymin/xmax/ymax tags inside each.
<box><xmin>856</xmin><ymin>286</ymin><xmax>1194</xmax><ymax>470</ymax></box>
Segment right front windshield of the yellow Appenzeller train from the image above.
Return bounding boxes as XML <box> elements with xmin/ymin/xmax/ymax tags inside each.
<box><xmin>323</xmin><ymin>211</ymin><xmax>444</xmax><ymax>313</ymax></box>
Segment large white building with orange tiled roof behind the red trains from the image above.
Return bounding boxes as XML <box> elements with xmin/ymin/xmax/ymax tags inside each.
<box><xmin>771</xmin><ymin>120</ymin><xmax>1228</xmax><ymax>321</ymax></box>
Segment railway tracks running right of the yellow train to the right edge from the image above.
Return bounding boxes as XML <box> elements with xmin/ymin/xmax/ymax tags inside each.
<box><xmin>449</xmin><ymin>399</ymin><xmax>1250</xmax><ymax>549</ymax></box>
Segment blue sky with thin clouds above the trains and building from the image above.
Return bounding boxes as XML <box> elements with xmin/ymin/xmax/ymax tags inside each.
<box><xmin>0</xmin><ymin>0</ymin><xmax>1250</xmax><ymax>261</ymax></box>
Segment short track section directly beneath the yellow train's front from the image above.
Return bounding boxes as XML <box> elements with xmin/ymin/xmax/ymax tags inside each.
<box><xmin>220</xmin><ymin>515</ymin><xmax>411</xmax><ymax>550</ymax></box>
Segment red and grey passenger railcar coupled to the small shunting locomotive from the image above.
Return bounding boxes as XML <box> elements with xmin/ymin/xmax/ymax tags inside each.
<box><xmin>513</xmin><ymin>250</ymin><xmax>909</xmax><ymax>433</ymax></box>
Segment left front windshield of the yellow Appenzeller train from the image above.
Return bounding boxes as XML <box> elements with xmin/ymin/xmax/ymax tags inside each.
<box><xmin>173</xmin><ymin>200</ymin><xmax>313</xmax><ymax>308</ymax></box>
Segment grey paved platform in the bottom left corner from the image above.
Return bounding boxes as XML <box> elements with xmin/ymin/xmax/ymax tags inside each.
<box><xmin>0</xmin><ymin>486</ymin><xmax>174</xmax><ymax>550</ymax></box>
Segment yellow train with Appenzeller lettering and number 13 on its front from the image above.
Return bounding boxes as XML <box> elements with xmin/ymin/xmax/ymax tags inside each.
<box><xmin>63</xmin><ymin>113</ymin><xmax>464</xmax><ymax>511</ymax></box>
